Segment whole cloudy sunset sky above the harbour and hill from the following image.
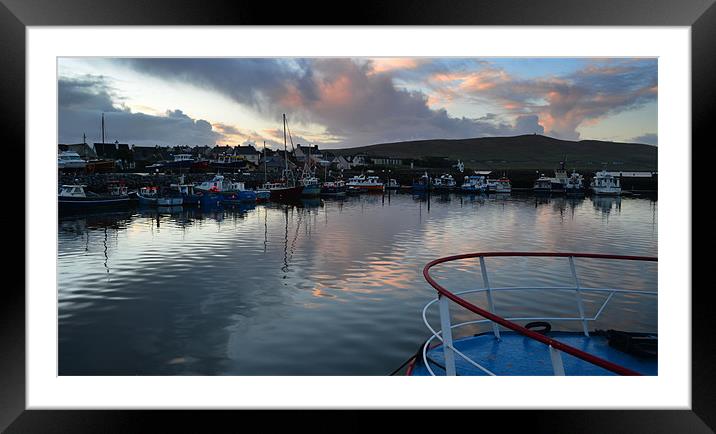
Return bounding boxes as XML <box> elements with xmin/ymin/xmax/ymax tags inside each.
<box><xmin>58</xmin><ymin>58</ymin><xmax>658</xmax><ymax>148</ymax></box>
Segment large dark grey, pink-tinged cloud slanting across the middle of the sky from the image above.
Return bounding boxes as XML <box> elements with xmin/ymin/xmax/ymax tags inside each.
<box><xmin>113</xmin><ymin>58</ymin><xmax>544</xmax><ymax>146</ymax></box>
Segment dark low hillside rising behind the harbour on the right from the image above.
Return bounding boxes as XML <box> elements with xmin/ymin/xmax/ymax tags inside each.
<box><xmin>328</xmin><ymin>135</ymin><xmax>657</xmax><ymax>170</ymax></box>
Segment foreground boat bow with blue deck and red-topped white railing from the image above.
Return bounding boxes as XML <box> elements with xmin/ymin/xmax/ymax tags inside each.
<box><xmin>406</xmin><ymin>252</ymin><xmax>658</xmax><ymax>376</ymax></box>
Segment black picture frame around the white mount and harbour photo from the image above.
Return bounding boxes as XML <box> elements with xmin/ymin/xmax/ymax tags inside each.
<box><xmin>0</xmin><ymin>0</ymin><xmax>704</xmax><ymax>433</ymax></box>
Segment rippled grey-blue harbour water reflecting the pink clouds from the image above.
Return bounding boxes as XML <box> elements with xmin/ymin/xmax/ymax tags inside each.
<box><xmin>58</xmin><ymin>194</ymin><xmax>657</xmax><ymax>375</ymax></box>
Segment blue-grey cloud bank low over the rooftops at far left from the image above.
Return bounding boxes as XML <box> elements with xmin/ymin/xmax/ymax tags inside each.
<box><xmin>58</xmin><ymin>76</ymin><xmax>223</xmax><ymax>145</ymax></box>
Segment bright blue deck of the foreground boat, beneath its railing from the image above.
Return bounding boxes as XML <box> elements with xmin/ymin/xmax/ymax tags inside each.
<box><xmin>412</xmin><ymin>331</ymin><xmax>658</xmax><ymax>376</ymax></box>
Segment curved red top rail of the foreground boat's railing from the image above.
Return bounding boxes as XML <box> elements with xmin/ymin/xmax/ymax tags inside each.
<box><xmin>422</xmin><ymin>252</ymin><xmax>658</xmax><ymax>375</ymax></box>
